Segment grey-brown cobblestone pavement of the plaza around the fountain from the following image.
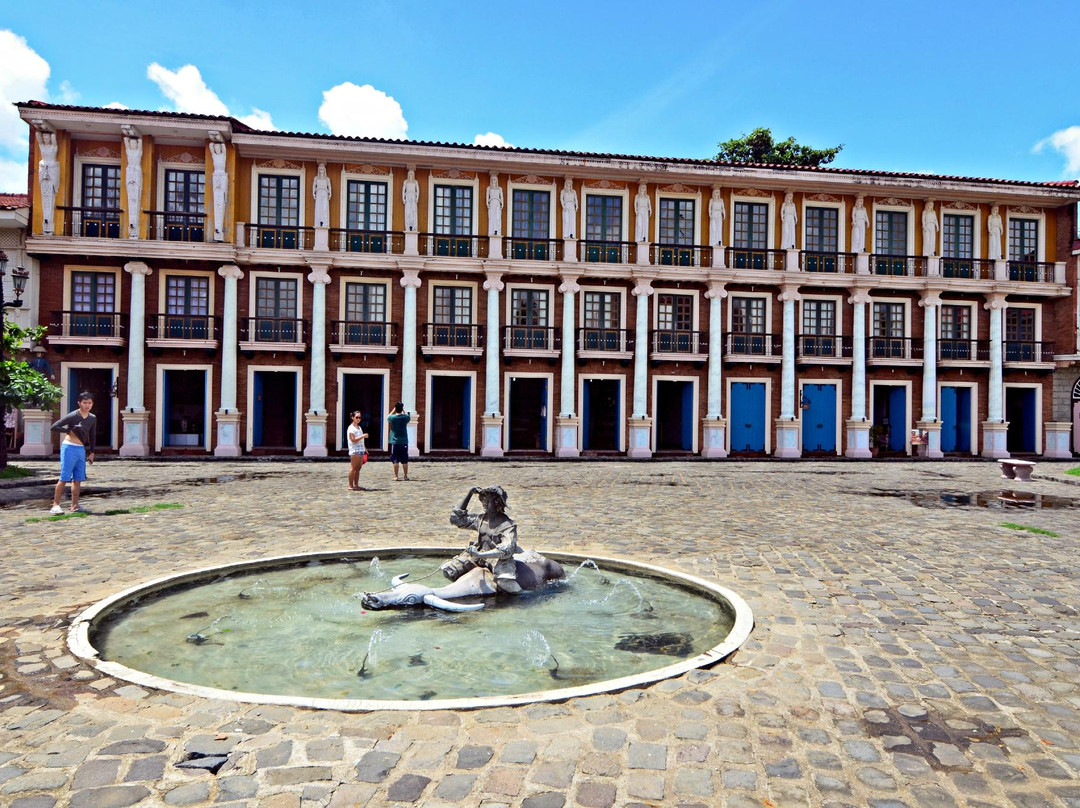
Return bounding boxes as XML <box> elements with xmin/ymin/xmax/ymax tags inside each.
<box><xmin>0</xmin><ymin>460</ymin><xmax>1080</xmax><ymax>808</ymax></box>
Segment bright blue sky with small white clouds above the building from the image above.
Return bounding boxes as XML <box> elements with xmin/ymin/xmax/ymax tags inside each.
<box><xmin>0</xmin><ymin>0</ymin><xmax>1080</xmax><ymax>192</ymax></box>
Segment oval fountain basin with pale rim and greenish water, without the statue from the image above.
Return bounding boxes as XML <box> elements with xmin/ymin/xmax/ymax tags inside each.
<box><xmin>68</xmin><ymin>548</ymin><xmax>753</xmax><ymax>711</ymax></box>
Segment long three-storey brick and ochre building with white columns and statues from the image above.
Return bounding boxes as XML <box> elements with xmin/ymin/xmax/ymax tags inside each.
<box><xmin>18</xmin><ymin>102</ymin><xmax>1080</xmax><ymax>458</ymax></box>
